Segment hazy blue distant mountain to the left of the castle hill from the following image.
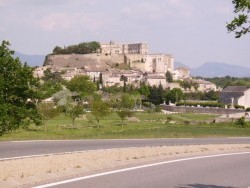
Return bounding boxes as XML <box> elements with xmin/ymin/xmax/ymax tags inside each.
<box><xmin>14</xmin><ymin>51</ymin><xmax>46</xmax><ymax>67</ymax></box>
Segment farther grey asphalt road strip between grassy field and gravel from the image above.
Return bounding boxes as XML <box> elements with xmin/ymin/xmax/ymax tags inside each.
<box><xmin>0</xmin><ymin>137</ymin><xmax>250</xmax><ymax>160</ymax></box>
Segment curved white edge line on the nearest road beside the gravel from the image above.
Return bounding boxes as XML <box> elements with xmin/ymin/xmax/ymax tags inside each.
<box><xmin>33</xmin><ymin>152</ymin><xmax>250</xmax><ymax>188</ymax></box>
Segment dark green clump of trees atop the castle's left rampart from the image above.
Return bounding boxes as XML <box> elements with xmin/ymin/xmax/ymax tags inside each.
<box><xmin>53</xmin><ymin>41</ymin><xmax>100</xmax><ymax>54</ymax></box>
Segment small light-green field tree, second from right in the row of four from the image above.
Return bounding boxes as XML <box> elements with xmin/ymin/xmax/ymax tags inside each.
<box><xmin>90</xmin><ymin>95</ymin><xmax>110</xmax><ymax>127</ymax></box>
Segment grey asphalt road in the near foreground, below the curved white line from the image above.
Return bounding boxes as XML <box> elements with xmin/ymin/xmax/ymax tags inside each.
<box><xmin>38</xmin><ymin>153</ymin><xmax>250</xmax><ymax>188</ymax></box>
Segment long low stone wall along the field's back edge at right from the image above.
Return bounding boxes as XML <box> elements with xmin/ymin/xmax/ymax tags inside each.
<box><xmin>161</xmin><ymin>104</ymin><xmax>245</xmax><ymax>115</ymax></box>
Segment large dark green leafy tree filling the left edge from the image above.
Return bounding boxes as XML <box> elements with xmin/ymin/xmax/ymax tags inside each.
<box><xmin>0</xmin><ymin>41</ymin><xmax>41</xmax><ymax>135</ymax></box>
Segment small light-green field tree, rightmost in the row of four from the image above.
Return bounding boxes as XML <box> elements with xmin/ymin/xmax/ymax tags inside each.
<box><xmin>117</xmin><ymin>93</ymin><xmax>135</xmax><ymax>127</ymax></box>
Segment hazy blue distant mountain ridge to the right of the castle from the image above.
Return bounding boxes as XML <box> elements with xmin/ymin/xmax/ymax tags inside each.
<box><xmin>175</xmin><ymin>62</ymin><xmax>250</xmax><ymax>78</ymax></box>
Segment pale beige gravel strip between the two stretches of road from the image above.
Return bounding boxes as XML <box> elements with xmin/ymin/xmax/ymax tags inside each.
<box><xmin>0</xmin><ymin>144</ymin><xmax>250</xmax><ymax>188</ymax></box>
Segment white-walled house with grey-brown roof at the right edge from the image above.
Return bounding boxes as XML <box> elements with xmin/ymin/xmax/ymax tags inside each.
<box><xmin>219</xmin><ymin>86</ymin><xmax>250</xmax><ymax>108</ymax></box>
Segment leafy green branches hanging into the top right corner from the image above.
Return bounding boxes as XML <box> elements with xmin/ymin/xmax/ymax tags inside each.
<box><xmin>227</xmin><ymin>0</ymin><xmax>250</xmax><ymax>38</ymax></box>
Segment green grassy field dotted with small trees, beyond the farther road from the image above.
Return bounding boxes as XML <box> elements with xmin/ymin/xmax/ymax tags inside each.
<box><xmin>0</xmin><ymin>112</ymin><xmax>250</xmax><ymax>141</ymax></box>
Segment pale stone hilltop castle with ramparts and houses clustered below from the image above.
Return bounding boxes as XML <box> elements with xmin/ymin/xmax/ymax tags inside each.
<box><xmin>34</xmin><ymin>41</ymin><xmax>217</xmax><ymax>90</ymax></box>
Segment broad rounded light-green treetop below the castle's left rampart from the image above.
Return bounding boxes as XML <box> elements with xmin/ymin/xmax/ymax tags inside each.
<box><xmin>67</xmin><ymin>75</ymin><xmax>96</xmax><ymax>97</ymax></box>
